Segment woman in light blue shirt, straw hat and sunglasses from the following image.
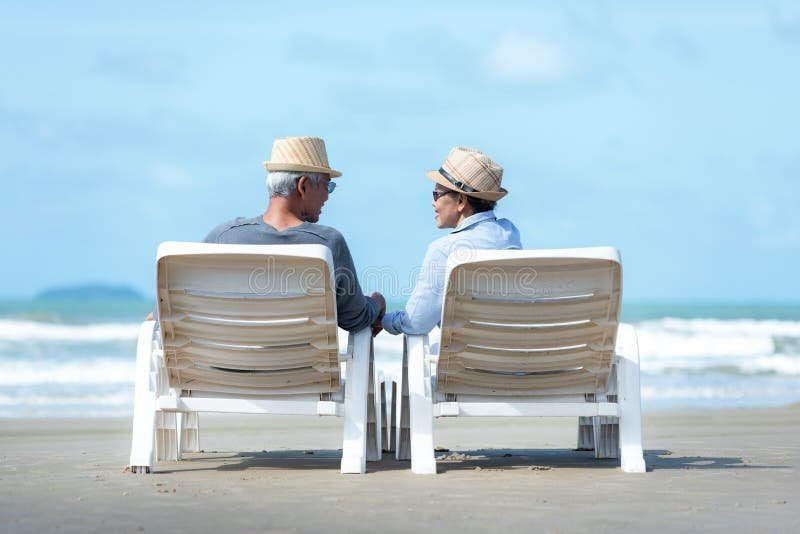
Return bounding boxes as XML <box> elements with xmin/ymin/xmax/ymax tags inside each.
<box><xmin>381</xmin><ymin>147</ymin><xmax>522</xmax><ymax>335</ymax></box>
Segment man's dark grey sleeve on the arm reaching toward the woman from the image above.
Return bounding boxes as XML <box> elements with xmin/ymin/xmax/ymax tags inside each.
<box><xmin>334</xmin><ymin>234</ymin><xmax>380</xmax><ymax>332</ymax></box>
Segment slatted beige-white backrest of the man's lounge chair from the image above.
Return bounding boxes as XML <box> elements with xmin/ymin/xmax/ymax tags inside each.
<box><xmin>157</xmin><ymin>242</ymin><xmax>340</xmax><ymax>396</ymax></box>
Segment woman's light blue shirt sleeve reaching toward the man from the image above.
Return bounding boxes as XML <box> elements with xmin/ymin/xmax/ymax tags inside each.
<box><xmin>381</xmin><ymin>241</ymin><xmax>447</xmax><ymax>335</ymax></box>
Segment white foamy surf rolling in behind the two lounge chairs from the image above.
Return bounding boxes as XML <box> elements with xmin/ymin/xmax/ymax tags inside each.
<box><xmin>0</xmin><ymin>317</ymin><xmax>800</xmax><ymax>416</ymax></box>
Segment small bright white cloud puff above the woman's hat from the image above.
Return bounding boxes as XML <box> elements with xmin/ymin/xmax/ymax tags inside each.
<box><xmin>485</xmin><ymin>30</ymin><xmax>567</xmax><ymax>83</ymax></box>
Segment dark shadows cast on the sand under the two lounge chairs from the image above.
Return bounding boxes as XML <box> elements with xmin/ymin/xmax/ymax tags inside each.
<box><xmin>157</xmin><ymin>449</ymin><xmax>788</xmax><ymax>474</ymax></box>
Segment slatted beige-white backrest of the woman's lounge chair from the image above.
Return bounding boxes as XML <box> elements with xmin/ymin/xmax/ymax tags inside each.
<box><xmin>436</xmin><ymin>247</ymin><xmax>622</xmax><ymax>396</ymax></box>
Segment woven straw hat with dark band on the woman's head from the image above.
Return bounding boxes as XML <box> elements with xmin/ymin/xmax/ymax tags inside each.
<box><xmin>427</xmin><ymin>147</ymin><xmax>508</xmax><ymax>201</ymax></box>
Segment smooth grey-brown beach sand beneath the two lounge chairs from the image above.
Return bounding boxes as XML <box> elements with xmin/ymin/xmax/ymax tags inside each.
<box><xmin>0</xmin><ymin>408</ymin><xmax>800</xmax><ymax>532</ymax></box>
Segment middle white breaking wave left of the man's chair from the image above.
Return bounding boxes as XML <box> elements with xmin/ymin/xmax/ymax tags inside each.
<box><xmin>0</xmin><ymin>355</ymin><xmax>136</xmax><ymax>386</ymax></box>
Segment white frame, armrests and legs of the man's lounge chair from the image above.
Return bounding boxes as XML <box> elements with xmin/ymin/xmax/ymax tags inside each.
<box><xmin>129</xmin><ymin>243</ymin><xmax>383</xmax><ymax>473</ymax></box>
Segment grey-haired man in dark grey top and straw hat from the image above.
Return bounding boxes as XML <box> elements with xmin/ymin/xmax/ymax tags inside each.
<box><xmin>205</xmin><ymin>137</ymin><xmax>386</xmax><ymax>333</ymax></box>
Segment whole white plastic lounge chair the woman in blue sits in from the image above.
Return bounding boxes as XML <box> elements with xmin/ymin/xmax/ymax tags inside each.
<box><xmin>393</xmin><ymin>247</ymin><xmax>645</xmax><ymax>473</ymax></box>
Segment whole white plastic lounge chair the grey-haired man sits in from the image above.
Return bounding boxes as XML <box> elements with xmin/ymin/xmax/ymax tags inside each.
<box><xmin>130</xmin><ymin>242</ymin><xmax>382</xmax><ymax>473</ymax></box>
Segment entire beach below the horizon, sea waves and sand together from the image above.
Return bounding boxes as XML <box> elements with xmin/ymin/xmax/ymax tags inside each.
<box><xmin>0</xmin><ymin>300</ymin><xmax>800</xmax><ymax>532</ymax></box>
